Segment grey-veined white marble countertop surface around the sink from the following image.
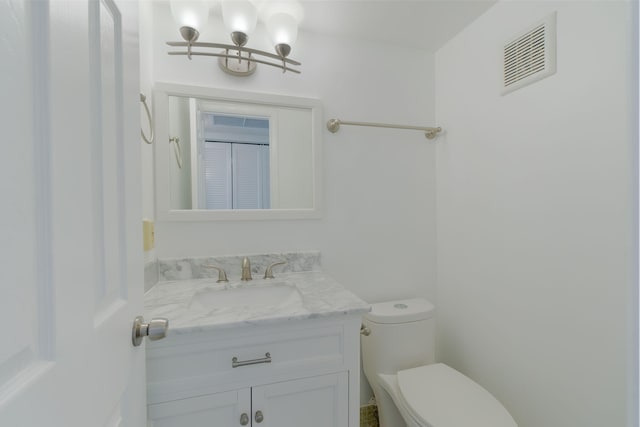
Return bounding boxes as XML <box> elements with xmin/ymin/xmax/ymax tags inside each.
<box><xmin>145</xmin><ymin>271</ymin><xmax>371</xmax><ymax>334</ymax></box>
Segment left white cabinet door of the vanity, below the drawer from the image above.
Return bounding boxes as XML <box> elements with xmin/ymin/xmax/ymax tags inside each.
<box><xmin>148</xmin><ymin>388</ymin><xmax>251</xmax><ymax>427</ymax></box>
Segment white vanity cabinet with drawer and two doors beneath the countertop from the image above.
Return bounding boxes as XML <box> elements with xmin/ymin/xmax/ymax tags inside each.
<box><xmin>147</xmin><ymin>315</ymin><xmax>361</xmax><ymax>427</ymax></box>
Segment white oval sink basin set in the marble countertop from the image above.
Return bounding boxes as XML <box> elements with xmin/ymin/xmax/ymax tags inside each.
<box><xmin>190</xmin><ymin>282</ymin><xmax>302</xmax><ymax>311</ymax></box>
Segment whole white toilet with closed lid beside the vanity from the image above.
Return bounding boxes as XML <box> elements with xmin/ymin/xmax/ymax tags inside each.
<box><xmin>361</xmin><ymin>298</ymin><xmax>517</xmax><ymax>427</ymax></box>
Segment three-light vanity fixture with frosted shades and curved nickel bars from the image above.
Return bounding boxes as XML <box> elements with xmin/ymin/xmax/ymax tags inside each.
<box><xmin>167</xmin><ymin>0</ymin><xmax>304</xmax><ymax>76</ymax></box>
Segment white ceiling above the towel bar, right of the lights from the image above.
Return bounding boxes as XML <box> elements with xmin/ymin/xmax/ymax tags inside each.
<box><xmin>300</xmin><ymin>0</ymin><xmax>496</xmax><ymax>52</ymax></box>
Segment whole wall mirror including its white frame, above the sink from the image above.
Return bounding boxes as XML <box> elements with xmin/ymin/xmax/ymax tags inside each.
<box><xmin>154</xmin><ymin>83</ymin><xmax>322</xmax><ymax>221</ymax></box>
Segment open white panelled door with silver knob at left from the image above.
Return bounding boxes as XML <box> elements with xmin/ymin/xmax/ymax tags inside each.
<box><xmin>0</xmin><ymin>0</ymin><xmax>145</xmax><ymax>427</ymax></box>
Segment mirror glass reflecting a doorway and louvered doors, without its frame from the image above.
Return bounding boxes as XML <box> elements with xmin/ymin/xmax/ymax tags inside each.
<box><xmin>169</xmin><ymin>96</ymin><xmax>313</xmax><ymax>210</ymax></box>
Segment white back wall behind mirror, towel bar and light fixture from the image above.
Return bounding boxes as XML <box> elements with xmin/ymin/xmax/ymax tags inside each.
<box><xmin>141</xmin><ymin>3</ymin><xmax>435</xmax><ymax>301</ymax></box>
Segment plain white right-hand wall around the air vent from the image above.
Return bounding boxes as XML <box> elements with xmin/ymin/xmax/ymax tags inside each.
<box><xmin>436</xmin><ymin>1</ymin><xmax>637</xmax><ymax>427</ymax></box>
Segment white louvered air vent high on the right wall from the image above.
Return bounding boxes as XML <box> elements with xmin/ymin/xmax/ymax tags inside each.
<box><xmin>502</xmin><ymin>12</ymin><xmax>556</xmax><ymax>95</ymax></box>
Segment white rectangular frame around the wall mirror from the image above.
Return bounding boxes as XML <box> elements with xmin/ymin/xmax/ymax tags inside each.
<box><xmin>153</xmin><ymin>83</ymin><xmax>323</xmax><ymax>222</ymax></box>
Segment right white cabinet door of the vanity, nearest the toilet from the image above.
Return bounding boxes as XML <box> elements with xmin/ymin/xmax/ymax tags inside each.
<box><xmin>252</xmin><ymin>372</ymin><xmax>349</xmax><ymax>427</ymax></box>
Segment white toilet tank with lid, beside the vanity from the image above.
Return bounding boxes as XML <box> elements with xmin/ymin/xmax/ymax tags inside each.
<box><xmin>361</xmin><ymin>298</ymin><xmax>435</xmax><ymax>378</ymax></box>
